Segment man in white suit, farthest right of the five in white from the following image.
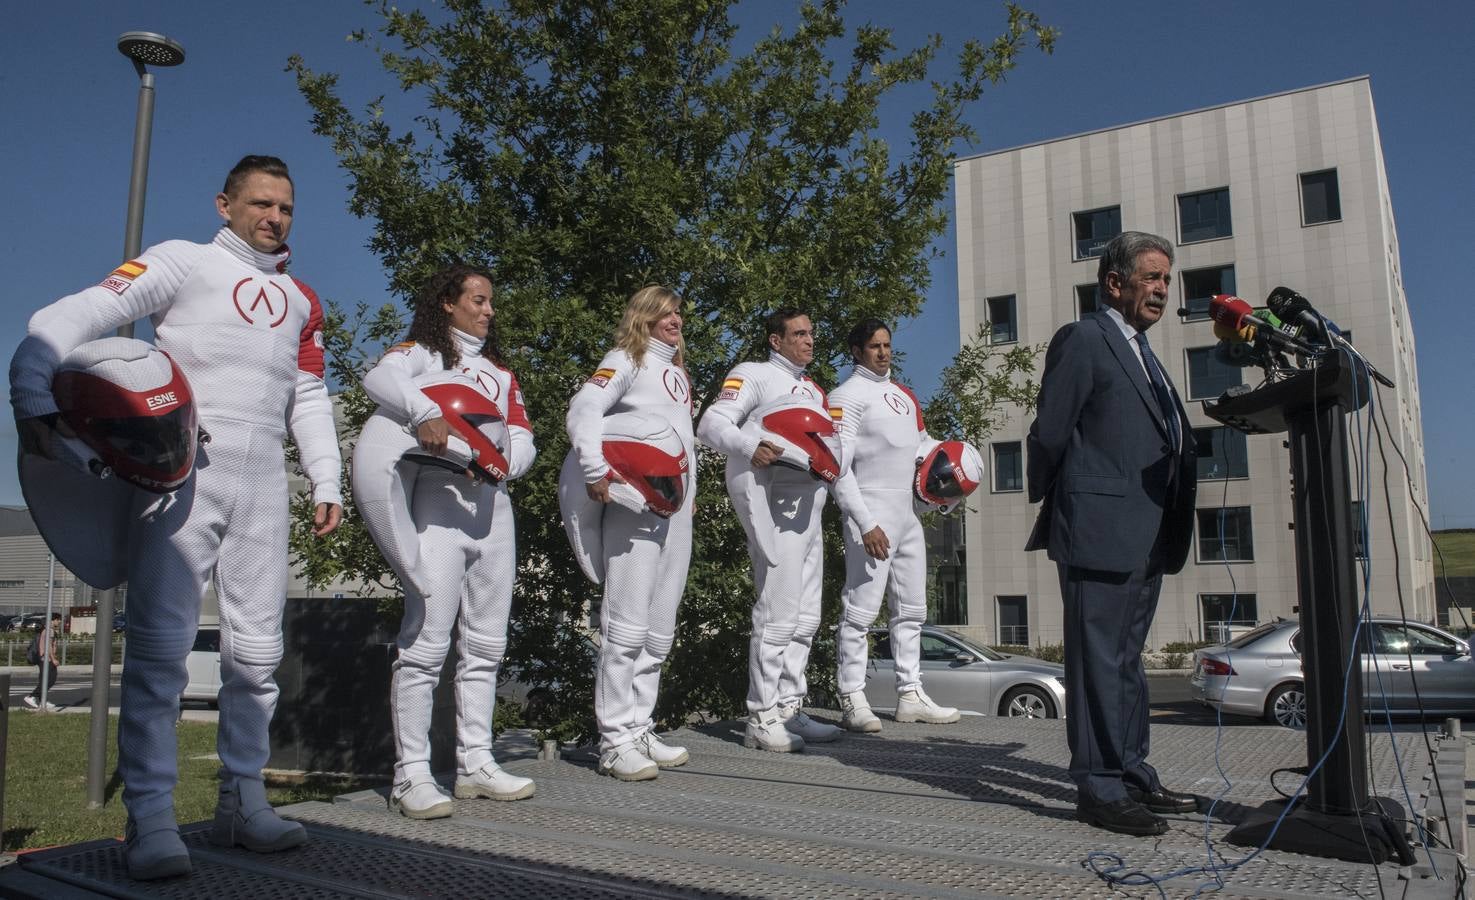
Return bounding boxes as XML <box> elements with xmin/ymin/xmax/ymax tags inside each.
<box><xmin>830</xmin><ymin>319</ymin><xmax>959</xmax><ymax>732</ymax></box>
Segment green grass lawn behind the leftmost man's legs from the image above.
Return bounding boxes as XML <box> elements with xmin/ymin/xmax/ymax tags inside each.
<box><xmin>3</xmin><ymin>710</ymin><xmax>363</xmax><ymax>850</ymax></box>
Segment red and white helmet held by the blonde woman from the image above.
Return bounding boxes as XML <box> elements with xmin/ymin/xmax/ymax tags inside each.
<box><xmin>603</xmin><ymin>413</ymin><xmax>692</xmax><ymax>518</ymax></box>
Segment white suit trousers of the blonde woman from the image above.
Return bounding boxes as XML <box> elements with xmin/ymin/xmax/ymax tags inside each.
<box><xmin>594</xmin><ymin>497</ymin><xmax>692</xmax><ymax>751</ymax></box>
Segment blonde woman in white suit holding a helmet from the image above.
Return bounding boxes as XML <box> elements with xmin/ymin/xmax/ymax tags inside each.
<box><xmin>565</xmin><ymin>286</ymin><xmax>696</xmax><ymax>780</ymax></box>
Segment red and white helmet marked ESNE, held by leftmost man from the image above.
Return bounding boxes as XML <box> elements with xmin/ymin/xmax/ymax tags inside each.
<box><xmin>52</xmin><ymin>338</ymin><xmax>199</xmax><ymax>494</ymax></box>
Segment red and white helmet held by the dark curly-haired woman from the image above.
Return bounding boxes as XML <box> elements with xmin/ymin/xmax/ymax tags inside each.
<box><xmin>404</xmin><ymin>372</ymin><xmax>510</xmax><ymax>482</ymax></box>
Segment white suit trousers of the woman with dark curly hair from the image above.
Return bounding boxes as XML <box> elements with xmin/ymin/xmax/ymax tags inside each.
<box><xmin>389</xmin><ymin>463</ymin><xmax>518</xmax><ymax>782</ymax></box>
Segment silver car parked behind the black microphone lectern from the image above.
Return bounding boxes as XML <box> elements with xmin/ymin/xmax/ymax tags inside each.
<box><xmin>1189</xmin><ymin>618</ymin><xmax>1475</xmax><ymax>727</ymax></box>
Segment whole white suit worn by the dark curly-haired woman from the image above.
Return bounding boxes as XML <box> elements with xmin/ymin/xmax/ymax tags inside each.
<box><xmin>354</xmin><ymin>328</ymin><xmax>537</xmax><ymax>819</ymax></box>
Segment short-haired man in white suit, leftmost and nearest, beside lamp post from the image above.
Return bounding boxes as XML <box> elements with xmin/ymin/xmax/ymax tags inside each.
<box><xmin>10</xmin><ymin>156</ymin><xmax>342</xmax><ymax>878</ymax></box>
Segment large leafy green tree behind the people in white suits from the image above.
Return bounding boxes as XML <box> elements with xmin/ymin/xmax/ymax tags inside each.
<box><xmin>289</xmin><ymin>0</ymin><xmax>1055</xmax><ymax>727</ymax></box>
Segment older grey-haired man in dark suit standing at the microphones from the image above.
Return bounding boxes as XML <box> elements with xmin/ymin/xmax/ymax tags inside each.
<box><xmin>1025</xmin><ymin>232</ymin><xmax>1196</xmax><ymax>835</ymax></box>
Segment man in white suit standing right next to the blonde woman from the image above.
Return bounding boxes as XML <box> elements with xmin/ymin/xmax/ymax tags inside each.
<box><xmin>696</xmin><ymin>308</ymin><xmax>841</xmax><ymax>752</ymax></box>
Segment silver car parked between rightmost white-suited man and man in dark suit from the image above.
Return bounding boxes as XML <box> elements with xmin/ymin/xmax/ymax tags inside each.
<box><xmin>866</xmin><ymin>626</ymin><xmax>1065</xmax><ymax>719</ymax></box>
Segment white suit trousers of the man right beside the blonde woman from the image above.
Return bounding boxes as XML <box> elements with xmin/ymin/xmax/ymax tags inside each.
<box><xmin>729</xmin><ymin>466</ymin><xmax>829</xmax><ymax>714</ymax></box>
